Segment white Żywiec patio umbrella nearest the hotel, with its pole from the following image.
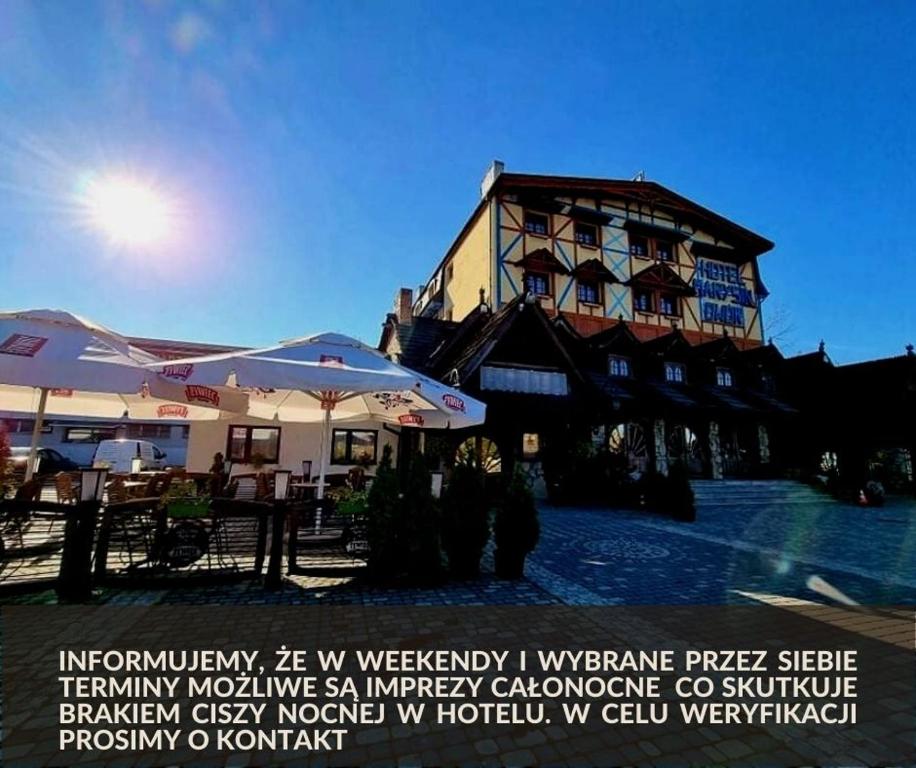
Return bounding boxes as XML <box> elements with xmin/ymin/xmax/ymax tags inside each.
<box><xmin>148</xmin><ymin>333</ymin><xmax>486</xmax><ymax>498</ymax></box>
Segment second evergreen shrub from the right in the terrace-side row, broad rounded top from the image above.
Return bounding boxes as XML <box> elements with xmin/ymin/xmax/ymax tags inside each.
<box><xmin>442</xmin><ymin>460</ymin><xmax>490</xmax><ymax>578</ymax></box>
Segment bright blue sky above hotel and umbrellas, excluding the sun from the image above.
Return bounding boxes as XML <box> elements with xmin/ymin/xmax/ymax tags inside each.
<box><xmin>0</xmin><ymin>0</ymin><xmax>916</xmax><ymax>361</ymax></box>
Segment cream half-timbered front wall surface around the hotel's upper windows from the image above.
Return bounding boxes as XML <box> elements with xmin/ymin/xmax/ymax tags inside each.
<box><xmin>494</xmin><ymin>197</ymin><xmax>763</xmax><ymax>341</ymax></box>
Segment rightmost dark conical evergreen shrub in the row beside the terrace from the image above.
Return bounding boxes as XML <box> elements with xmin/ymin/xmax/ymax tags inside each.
<box><xmin>493</xmin><ymin>467</ymin><xmax>541</xmax><ymax>579</ymax></box>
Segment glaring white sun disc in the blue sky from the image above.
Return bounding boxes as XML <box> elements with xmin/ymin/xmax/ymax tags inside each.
<box><xmin>84</xmin><ymin>176</ymin><xmax>174</xmax><ymax>246</ymax></box>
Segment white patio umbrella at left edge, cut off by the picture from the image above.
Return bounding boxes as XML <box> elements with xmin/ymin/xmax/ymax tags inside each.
<box><xmin>0</xmin><ymin>309</ymin><xmax>247</xmax><ymax>480</ymax></box>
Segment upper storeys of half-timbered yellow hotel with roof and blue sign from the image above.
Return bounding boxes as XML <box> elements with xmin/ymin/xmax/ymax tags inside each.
<box><xmin>413</xmin><ymin>163</ymin><xmax>773</xmax><ymax>349</ymax></box>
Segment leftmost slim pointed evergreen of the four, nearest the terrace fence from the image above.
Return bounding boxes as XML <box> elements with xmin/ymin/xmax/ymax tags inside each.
<box><xmin>366</xmin><ymin>445</ymin><xmax>404</xmax><ymax>580</ymax></box>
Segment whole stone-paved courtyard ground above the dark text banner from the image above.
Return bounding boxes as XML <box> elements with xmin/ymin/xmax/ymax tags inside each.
<box><xmin>1</xmin><ymin>482</ymin><xmax>916</xmax><ymax>605</ymax></box>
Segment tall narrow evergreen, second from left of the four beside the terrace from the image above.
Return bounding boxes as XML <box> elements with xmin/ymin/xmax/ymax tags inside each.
<box><xmin>403</xmin><ymin>453</ymin><xmax>442</xmax><ymax>583</ymax></box>
